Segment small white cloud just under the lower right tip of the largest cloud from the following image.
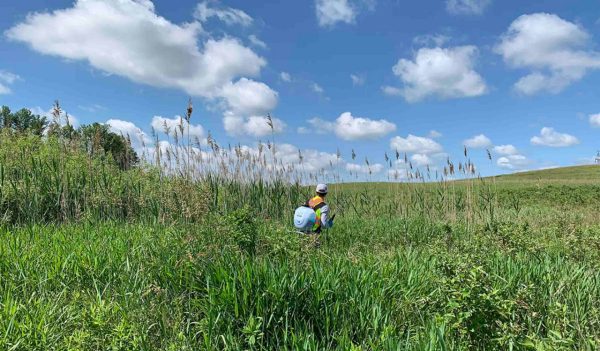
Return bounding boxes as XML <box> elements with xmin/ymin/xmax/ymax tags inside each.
<box><xmin>223</xmin><ymin>112</ymin><xmax>286</xmax><ymax>137</ymax></box>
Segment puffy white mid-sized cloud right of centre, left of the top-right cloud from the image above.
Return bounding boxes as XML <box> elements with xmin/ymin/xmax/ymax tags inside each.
<box><xmin>390</xmin><ymin>46</ymin><xmax>487</xmax><ymax>102</ymax></box>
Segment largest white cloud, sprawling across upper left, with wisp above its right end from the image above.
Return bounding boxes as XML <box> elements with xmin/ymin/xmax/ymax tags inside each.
<box><xmin>6</xmin><ymin>0</ymin><xmax>278</xmax><ymax>137</ymax></box>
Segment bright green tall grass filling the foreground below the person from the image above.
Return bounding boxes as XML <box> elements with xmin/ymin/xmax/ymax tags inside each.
<box><xmin>0</xmin><ymin>219</ymin><xmax>600</xmax><ymax>350</ymax></box>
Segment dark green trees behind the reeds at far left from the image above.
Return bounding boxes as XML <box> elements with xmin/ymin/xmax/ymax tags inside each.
<box><xmin>0</xmin><ymin>101</ymin><xmax>139</xmax><ymax>170</ymax></box>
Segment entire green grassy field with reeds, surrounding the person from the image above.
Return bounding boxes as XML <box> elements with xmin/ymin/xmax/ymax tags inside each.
<box><xmin>0</xmin><ymin>136</ymin><xmax>600</xmax><ymax>350</ymax></box>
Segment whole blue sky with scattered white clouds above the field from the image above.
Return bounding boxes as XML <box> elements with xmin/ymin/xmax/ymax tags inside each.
<box><xmin>0</xmin><ymin>0</ymin><xmax>600</xmax><ymax>178</ymax></box>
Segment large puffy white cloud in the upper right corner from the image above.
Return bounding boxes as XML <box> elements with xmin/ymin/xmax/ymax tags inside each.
<box><xmin>494</xmin><ymin>13</ymin><xmax>600</xmax><ymax>95</ymax></box>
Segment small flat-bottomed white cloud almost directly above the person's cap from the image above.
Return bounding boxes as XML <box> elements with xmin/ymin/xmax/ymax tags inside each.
<box><xmin>302</xmin><ymin>112</ymin><xmax>396</xmax><ymax>141</ymax></box>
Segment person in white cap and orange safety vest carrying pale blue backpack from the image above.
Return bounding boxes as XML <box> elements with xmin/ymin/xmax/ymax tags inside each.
<box><xmin>294</xmin><ymin>184</ymin><xmax>335</xmax><ymax>234</ymax></box>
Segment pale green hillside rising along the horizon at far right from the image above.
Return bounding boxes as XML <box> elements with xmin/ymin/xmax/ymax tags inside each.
<box><xmin>495</xmin><ymin>165</ymin><xmax>600</xmax><ymax>183</ymax></box>
